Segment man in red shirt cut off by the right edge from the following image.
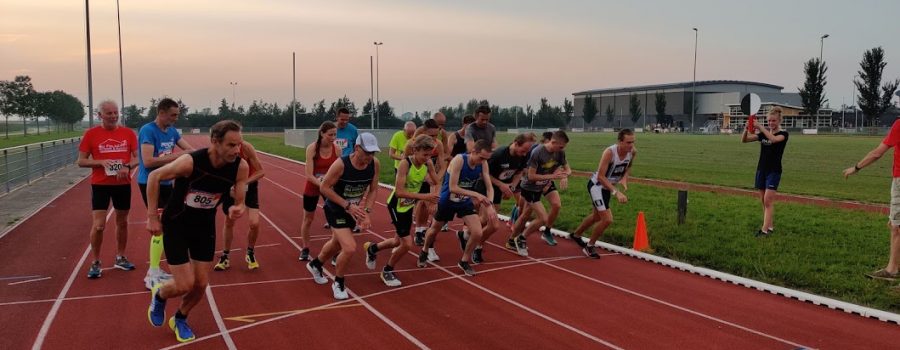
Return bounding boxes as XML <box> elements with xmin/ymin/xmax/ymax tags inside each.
<box><xmin>844</xmin><ymin>119</ymin><xmax>900</xmax><ymax>281</ymax></box>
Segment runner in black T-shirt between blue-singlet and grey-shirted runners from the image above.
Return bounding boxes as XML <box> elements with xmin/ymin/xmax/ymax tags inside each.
<box><xmin>464</xmin><ymin>132</ymin><xmax>535</xmax><ymax>264</ymax></box>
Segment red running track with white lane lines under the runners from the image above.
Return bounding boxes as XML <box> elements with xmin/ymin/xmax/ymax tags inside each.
<box><xmin>0</xmin><ymin>138</ymin><xmax>900</xmax><ymax>349</ymax></box>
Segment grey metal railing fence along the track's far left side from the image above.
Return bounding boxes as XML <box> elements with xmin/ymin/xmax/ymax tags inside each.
<box><xmin>0</xmin><ymin>137</ymin><xmax>81</xmax><ymax>194</ymax></box>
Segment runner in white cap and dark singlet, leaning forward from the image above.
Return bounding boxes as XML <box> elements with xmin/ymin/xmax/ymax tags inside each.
<box><xmin>306</xmin><ymin>133</ymin><xmax>380</xmax><ymax>300</ymax></box>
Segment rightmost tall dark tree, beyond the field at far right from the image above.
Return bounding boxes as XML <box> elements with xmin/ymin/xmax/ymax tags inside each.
<box><xmin>853</xmin><ymin>46</ymin><xmax>900</xmax><ymax>125</ymax></box>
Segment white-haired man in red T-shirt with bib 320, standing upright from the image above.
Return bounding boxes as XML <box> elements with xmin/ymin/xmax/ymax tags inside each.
<box><xmin>78</xmin><ymin>101</ymin><xmax>138</xmax><ymax>278</ymax></box>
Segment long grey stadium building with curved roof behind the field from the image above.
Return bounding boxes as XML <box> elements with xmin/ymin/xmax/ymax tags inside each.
<box><xmin>569</xmin><ymin>80</ymin><xmax>839</xmax><ymax>132</ymax></box>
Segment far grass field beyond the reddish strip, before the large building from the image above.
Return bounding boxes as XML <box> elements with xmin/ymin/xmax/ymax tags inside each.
<box><xmin>498</xmin><ymin>133</ymin><xmax>893</xmax><ymax>203</ymax></box>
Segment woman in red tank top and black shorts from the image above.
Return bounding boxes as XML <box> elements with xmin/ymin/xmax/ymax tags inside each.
<box><xmin>300</xmin><ymin>122</ymin><xmax>341</xmax><ymax>261</ymax></box>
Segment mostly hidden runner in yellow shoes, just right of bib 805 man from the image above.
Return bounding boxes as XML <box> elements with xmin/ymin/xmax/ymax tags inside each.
<box><xmin>214</xmin><ymin>141</ymin><xmax>266</xmax><ymax>271</ymax></box>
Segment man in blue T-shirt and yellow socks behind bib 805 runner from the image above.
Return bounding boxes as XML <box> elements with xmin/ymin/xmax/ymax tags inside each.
<box><xmin>138</xmin><ymin>98</ymin><xmax>194</xmax><ymax>290</ymax></box>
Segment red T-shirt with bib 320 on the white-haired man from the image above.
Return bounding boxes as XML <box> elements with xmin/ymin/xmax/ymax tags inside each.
<box><xmin>78</xmin><ymin>125</ymin><xmax>138</xmax><ymax>185</ymax></box>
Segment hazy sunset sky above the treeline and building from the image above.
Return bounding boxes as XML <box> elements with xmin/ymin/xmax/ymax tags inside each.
<box><xmin>0</xmin><ymin>0</ymin><xmax>900</xmax><ymax>115</ymax></box>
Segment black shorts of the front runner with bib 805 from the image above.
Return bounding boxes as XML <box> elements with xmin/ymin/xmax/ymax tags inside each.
<box><xmin>163</xmin><ymin>216</ymin><xmax>216</xmax><ymax>265</ymax></box>
